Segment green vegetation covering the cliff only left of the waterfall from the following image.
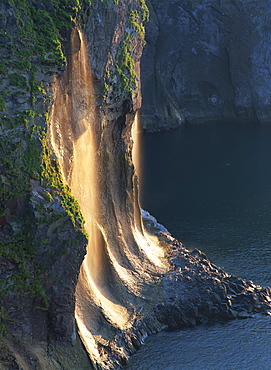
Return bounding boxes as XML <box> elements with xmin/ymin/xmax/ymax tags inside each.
<box><xmin>0</xmin><ymin>0</ymin><xmax>88</xmax><ymax>335</ymax></box>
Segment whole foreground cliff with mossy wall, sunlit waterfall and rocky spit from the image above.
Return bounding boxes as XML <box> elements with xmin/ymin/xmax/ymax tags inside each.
<box><xmin>0</xmin><ymin>0</ymin><xmax>271</xmax><ymax>370</ymax></box>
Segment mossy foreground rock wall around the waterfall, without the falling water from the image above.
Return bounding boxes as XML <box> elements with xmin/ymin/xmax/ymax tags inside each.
<box><xmin>0</xmin><ymin>0</ymin><xmax>147</xmax><ymax>369</ymax></box>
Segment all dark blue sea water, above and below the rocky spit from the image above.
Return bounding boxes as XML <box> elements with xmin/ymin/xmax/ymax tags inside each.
<box><xmin>128</xmin><ymin>124</ymin><xmax>271</xmax><ymax>370</ymax></box>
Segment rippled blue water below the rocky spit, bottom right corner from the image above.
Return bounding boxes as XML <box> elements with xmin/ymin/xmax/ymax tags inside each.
<box><xmin>127</xmin><ymin>315</ymin><xmax>271</xmax><ymax>370</ymax></box>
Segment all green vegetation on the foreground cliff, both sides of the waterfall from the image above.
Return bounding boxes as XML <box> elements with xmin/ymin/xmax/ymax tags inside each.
<box><xmin>0</xmin><ymin>0</ymin><xmax>149</xmax><ymax>334</ymax></box>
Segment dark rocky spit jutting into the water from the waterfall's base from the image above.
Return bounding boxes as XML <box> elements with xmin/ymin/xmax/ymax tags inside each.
<box><xmin>87</xmin><ymin>211</ymin><xmax>271</xmax><ymax>370</ymax></box>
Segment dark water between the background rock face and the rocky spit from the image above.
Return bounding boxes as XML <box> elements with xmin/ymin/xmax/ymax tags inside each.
<box><xmin>141</xmin><ymin>124</ymin><xmax>271</xmax><ymax>285</ymax></box>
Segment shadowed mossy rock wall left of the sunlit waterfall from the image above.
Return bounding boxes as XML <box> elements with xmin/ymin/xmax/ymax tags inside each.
<box><xmin>0</xmin><ymin>1</ymin><xmax>95</xmax><ymax>369</ymax></box>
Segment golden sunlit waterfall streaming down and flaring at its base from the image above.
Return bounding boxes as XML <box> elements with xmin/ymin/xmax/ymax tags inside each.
<box><xmin>47</xmin><ymin>28</ymin><xmax>168</xmax><ymax>363</ymax></box>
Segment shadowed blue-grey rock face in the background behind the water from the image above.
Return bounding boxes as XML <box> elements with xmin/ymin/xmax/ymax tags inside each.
<box><xmin>141</xmin><ymin>0</ymin><xmax>271</xmax><ymax>131</ymax></box>
